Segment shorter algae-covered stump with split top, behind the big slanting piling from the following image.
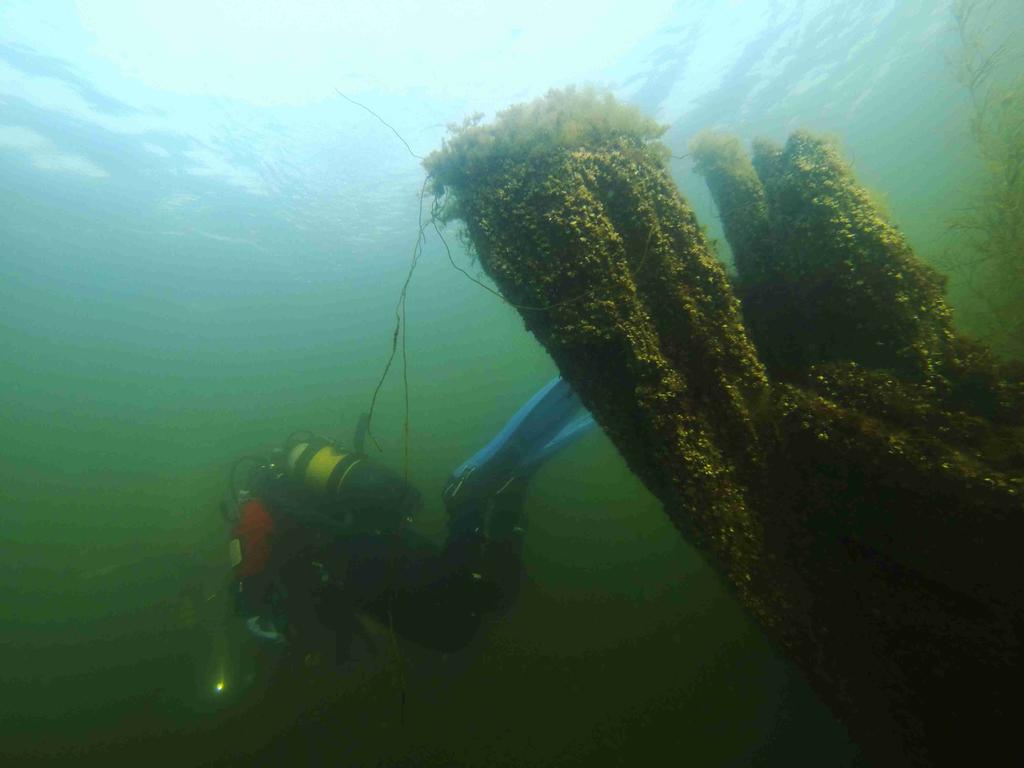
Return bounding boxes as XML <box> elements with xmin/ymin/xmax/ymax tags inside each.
<box><xmin>691</xmin><ymin>132</ymin><xmax>950</xmax><ymax>391</ymax></box>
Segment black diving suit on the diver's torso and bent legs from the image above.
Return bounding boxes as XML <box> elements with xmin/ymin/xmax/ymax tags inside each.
<box><xmin>239</xmin><ymin>466</ymin><xmax>526</xmax><ymax>663</ymax></box>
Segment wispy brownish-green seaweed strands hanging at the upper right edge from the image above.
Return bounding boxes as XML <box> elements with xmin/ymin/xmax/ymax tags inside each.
<box><xmin>946</xmin><ymin>0</ymin><xmax>1024</xmax><ymax>359</ymax></box>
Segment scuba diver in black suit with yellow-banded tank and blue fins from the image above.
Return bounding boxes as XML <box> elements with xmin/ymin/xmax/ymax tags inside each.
<box><xmin>223</xmin><ymin>378</ymin><xmax>594</xmax><ymax>664</ymax></box>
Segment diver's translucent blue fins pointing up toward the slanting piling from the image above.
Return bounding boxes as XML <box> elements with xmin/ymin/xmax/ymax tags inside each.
<box><xmin>442</xmin><ymin>377</ymin><xmax>594</xmax><ymax>542</ymax></box>
